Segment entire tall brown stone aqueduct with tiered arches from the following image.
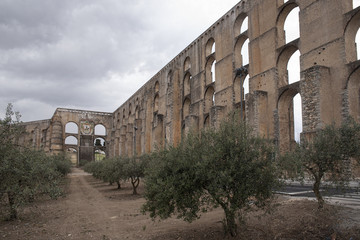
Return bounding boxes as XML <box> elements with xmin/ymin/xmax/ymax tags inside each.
<box><xmin>21</xmin><ymin>0</ymin><xmax>360</xmax><ymax>163</ymax></box>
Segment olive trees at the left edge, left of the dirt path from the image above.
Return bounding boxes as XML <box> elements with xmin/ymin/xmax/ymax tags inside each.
<box><xmin>0</xmin><ymin>104</ymin><xmax>71</xmax><ymax>219</ymax></box>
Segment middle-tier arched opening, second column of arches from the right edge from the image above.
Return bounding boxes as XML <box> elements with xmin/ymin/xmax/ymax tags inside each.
<box><xmin>277</xmin><ymin>45</ymin><xmax>300</xmax><ymax>88</ymax></box>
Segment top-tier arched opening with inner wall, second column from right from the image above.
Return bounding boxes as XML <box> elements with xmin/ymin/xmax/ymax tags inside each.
<box><xmin>276</xmin><ymin>2</ymin><xmax>300</xmax><ymax>47</ymax></box>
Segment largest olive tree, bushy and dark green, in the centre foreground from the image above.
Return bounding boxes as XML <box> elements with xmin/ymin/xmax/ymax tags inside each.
<box><xmin>143</xmin><ymin>117</ymin><xmax>279</xmax><ymax>236</ymax></box>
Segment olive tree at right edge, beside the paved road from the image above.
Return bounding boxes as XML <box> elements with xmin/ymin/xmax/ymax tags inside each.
<box><xmin>279</xmin><ymin>119</ymin><xmax>360</xmax><ymax>209</ymax></box>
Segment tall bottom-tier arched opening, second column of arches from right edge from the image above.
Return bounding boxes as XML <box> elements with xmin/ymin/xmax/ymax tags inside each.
<box><xmin>278</xmin><ymin>88</ymin><xmax>302</xmax><ymax>152</ymax></box>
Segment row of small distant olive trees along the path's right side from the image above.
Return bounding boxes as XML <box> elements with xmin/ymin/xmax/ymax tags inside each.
<box><xmin>84</xmin><ymin>155</ymin><xmax>149</xmax><ymax>195</ymax></box>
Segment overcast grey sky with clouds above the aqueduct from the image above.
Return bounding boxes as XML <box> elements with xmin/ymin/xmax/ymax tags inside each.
<box><xmin>0</xmin><ymin>0</ymin><xmax>239</xmax><ymax>121</ymax></box>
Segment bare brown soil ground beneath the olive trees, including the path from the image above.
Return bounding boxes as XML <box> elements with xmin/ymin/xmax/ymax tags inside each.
<box><xmin>0</xmin><ymin>169</ymin><xmax>360</xmax><ymax>240</ymax></box>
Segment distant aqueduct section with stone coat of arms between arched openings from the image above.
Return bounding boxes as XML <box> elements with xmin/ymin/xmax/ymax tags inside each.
<box><xmin>49</xmin><ymin>108</ymin><xmax>112</xmax><ymax>165</ymax></box>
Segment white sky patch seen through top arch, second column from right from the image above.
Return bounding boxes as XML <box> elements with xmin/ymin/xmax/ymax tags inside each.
<box><xmin>284</xmin><ymin>7</ymin><xmax>300</xmax><ymax>43</ymax></box>
